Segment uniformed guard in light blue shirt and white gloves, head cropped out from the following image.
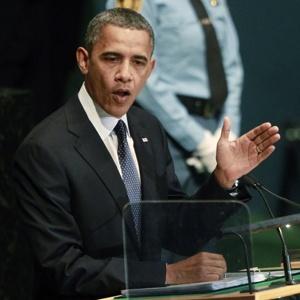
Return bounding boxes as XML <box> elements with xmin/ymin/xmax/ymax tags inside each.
<box><xmin>107</xmin><ymin>0</ymin><xmax>243</xmax><ymax>193</ymax></box>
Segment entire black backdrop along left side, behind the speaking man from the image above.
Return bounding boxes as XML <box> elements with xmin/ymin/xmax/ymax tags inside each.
<box><xmin>0</xmin><ymin>0</ymin><xmax>84</xmax><ymax>300</ymax></box>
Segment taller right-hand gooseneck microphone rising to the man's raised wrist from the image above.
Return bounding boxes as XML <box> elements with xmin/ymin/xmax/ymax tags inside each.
<box><xmin>241</xmin><ymin>175</ymin><xmax>296</xmax><ymax>285</ymax></box>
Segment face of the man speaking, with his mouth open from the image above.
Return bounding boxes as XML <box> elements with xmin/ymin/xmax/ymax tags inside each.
<box><xmin>76</xmin><ymin>25</ymin><xmax>154</xmax><ymax>118</ymax></box>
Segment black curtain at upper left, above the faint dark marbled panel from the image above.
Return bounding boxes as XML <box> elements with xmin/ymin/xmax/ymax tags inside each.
<box><xmin>0</xmin><ymin>0</ymin><xmax>84</xmax><ymax>122</ymax></box>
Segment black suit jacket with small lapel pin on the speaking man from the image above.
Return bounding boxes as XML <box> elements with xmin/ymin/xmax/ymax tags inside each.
<box><xmin>14</xmin><ymin>97</ymin><xmax>246</xmax><ymax>297</ymax></box>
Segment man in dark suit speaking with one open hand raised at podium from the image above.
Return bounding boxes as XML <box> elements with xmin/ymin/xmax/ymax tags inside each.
<box><xmin>15</xmin><ymin>9</ymin><xmax>280</xmax><ymax>297</ymax></box>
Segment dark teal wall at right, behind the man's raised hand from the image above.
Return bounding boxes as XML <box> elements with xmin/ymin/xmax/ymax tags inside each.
<box><xmin>227</xmin><ymin>0</ymin><xmax>300</xmax><ymax>266</ymax></box>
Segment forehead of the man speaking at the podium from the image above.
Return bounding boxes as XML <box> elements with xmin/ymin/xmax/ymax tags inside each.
<box><xmin>94</xmin><ymin>25</ymin><xmax>152</xmax><ymax>56</ymax></box>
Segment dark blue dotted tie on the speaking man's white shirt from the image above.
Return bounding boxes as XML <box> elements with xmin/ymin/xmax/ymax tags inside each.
<box><xmin>114</xmin><ymin>120</ymin><xmax>141</xmax><ymax>239</ymax></box>
